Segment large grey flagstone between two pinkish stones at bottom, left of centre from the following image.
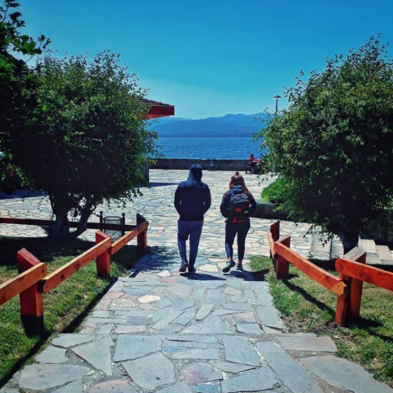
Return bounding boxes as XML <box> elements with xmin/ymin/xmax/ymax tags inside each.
<box><xmin>122</xmin><ymin>352</ymin><xmax>176</xmax><ymax>391</ymax></box>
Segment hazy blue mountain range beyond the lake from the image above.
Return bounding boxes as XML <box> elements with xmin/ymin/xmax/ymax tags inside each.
<box><xmin>150</xmin><ymin>113</ymin><xmax>269</xmax><ymax>137</ymax></box>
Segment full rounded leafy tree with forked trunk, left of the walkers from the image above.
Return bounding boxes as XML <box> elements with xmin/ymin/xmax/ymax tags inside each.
<box><xmin>11</xmin><ymin>52</ymin><xmax>156</xmax><ymax>238</ymax></box>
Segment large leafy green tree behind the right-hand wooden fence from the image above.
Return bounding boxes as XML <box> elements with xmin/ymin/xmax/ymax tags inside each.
<box><xmin>258</xmin><ymin>37</ymin><xmax>393</xmax><ymax>251</ymax></box>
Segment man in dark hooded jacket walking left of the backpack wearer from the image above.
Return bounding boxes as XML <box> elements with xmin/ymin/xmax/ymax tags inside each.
<box><xmin>175</xmin><ymin>164</ymin><xmax>211</xmax><ymax>273</ymax></box>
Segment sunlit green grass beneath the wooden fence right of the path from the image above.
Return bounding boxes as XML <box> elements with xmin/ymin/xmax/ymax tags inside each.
<box><xmin>251</xmin><ymin>257</ymin><xmax>393</xmax><ymax>387</ymax></box>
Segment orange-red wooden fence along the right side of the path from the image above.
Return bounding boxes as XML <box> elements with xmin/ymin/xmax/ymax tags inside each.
<box><xmin>267</xmin><ymin>221</ymin><xmax>393</xmax><ymax>326</ymax></box>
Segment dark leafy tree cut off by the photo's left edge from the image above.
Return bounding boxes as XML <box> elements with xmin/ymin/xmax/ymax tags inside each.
<box><xmin>0</xmin><ymin>0</ymin><xmax>49</xmax><ymax>188</ymax></box>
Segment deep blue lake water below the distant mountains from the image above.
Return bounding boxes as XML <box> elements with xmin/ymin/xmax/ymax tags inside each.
<box><xmin>158</xmin><ymin>137</ymin><xmax>261</xmax><ymax>160</ymax></box>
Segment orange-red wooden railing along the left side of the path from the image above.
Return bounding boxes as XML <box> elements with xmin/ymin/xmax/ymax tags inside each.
<box><xmin>0</xmin><ymin>214</ymin><xmax>149</xmax><ymax>327</ymax></box>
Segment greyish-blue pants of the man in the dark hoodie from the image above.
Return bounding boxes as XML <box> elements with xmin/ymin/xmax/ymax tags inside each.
<box><xmin>177</xmin><ymin>220</ymin><xmax>203</xmax><ymax>268</ymax></box>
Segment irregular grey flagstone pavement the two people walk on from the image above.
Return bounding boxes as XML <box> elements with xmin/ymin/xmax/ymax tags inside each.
<box><xmin>0</xmin><ymin>170</ymin><xmax>393</xmax><ymax>393</ymax></box>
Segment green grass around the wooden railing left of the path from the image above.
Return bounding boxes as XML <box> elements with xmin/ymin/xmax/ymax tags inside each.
<box><xmin>0</xmin><ymin>237</ymin><xmax>141</xmax><ymax>387</ymax></box>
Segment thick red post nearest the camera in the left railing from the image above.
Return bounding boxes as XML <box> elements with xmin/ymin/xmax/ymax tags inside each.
<box><xmin>16</xmin><ymin>248</ymin><xmax>44</xmax><ymax>328</ymax></box>
